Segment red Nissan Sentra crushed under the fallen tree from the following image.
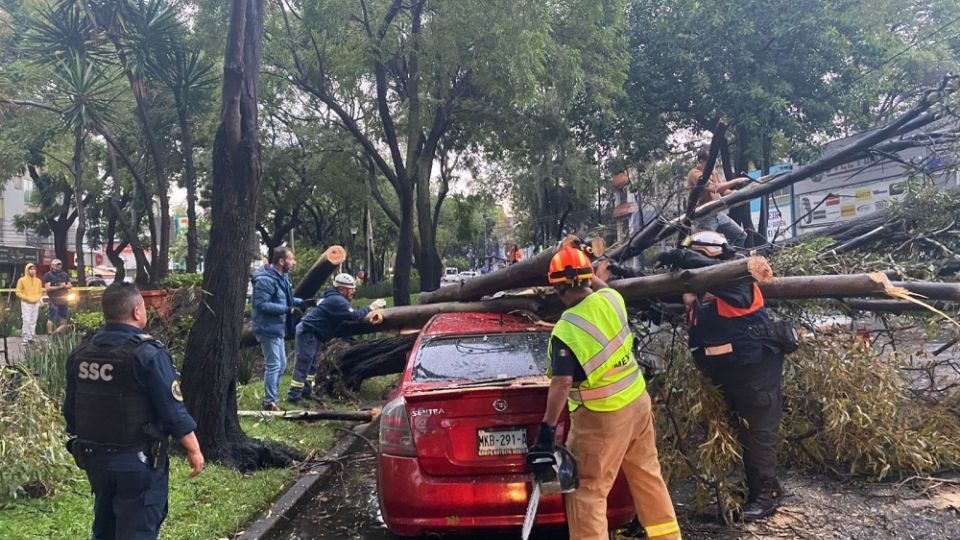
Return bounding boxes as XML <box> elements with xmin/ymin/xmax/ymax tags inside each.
<box><xmin>377</xmin><ymin>313</ymin><xmax>634</xmax><ymax>536</ymax></box>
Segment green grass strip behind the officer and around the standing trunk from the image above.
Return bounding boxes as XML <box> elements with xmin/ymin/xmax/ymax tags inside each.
<box><xmin>0</xmin><ymin>375</ymin><xmax>396</xmax><ymax>540</ymax></box>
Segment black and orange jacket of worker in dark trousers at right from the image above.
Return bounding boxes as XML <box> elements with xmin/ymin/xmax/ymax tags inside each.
<box><xmin>689</xmin><ymin>282</ymin><xmax>776</xmax><ymax>365</ymax></box>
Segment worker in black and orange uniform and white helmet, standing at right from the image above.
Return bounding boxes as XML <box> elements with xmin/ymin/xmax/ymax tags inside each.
<box><xmin>660</xmin><ymin>231</ymin><xmax>783</xmax><ymax>521</ymax></box>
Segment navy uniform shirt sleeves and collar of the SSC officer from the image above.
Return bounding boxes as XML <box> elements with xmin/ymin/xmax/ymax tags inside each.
<box><xmin>63</xmin><ymin>323</ymin><xmax>197</xmax><ymax>439</ymax></box>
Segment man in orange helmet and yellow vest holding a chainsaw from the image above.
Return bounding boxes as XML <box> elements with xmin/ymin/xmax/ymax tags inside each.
<box><xmin>527</xmin><ymin>247</ymin><xmax>680</xmax><ymax>540</ymax></box>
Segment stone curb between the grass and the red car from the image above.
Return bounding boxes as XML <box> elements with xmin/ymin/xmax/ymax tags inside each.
<box><xmin>233</xmin><ymin>415</ymin><xmax>380</xmax><ymax>540</ymax></box>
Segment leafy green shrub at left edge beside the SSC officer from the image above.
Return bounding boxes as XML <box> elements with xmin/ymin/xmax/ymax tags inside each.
<box><xmin>0</xmin><ymin>369</ymin><xmax>75</xmax><ymax>503</ymax></box>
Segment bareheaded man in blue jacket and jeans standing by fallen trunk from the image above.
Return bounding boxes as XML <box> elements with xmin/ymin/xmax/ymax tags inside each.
<box><xmin>251</xmin><ymin>246</ymin><xmax>303</xmax><ymax>411</ymax></box>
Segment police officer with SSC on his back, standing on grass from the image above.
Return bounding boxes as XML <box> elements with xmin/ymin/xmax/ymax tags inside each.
<box><xmin>63</xmin><ymin>283</ymin><xmax>203</xmax><ymax>540</ymax></box>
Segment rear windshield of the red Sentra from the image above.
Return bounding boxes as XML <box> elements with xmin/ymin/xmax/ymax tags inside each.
<box><xmin>413</xmin><ymin>332</ymin><xmax>550</xmax><ymax>383</ymax></box>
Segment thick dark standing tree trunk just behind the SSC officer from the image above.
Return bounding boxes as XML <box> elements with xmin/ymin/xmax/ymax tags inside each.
<box><xmin>183</xmin><ymin>0</ymin><xmax>296</xmax><ymax>470</ymax></box>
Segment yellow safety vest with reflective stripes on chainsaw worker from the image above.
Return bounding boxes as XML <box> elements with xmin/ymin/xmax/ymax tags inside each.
<box><xmin>547</xmin><ymin>289</ymin><xmax>647</xmax><ymax>412</ymax></box>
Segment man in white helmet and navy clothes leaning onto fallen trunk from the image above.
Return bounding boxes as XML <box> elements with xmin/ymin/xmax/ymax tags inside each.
<box><xmin>287</xmin><ymin>274</ymin><xmax>386</xmax><ymax>403</ymax></box>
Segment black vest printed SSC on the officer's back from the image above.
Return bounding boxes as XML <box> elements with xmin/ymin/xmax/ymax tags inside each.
<box><xmin>73</xmin><ymin>334</ymin><xmax>156</xmax><ymax>446</ymax></box>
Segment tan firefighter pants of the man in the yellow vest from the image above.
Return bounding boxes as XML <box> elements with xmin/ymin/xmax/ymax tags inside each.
<box><xmin>566</xmin><ymin>392</ymin><xmax>680</xmax><ymax>540</ymax></box>
